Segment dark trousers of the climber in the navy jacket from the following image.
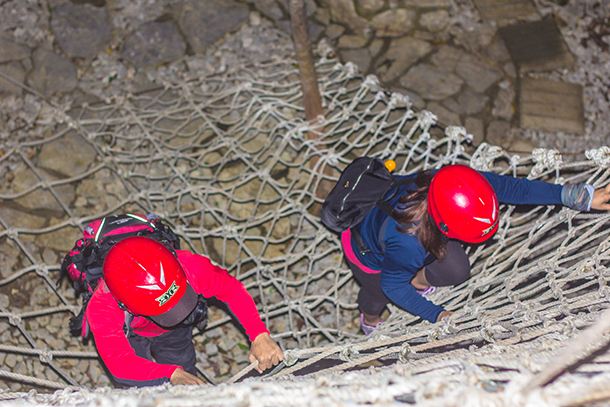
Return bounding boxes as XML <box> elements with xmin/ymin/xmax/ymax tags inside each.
<box><xmin>345</xmin><ymin>240</ymin><xmax>470</xmax><ymax>315</ymax></box>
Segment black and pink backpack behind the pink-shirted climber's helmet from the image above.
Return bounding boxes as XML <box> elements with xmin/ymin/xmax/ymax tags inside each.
<box><xmin>57</xmin><ymin>214</ymin><xmax>192</xmax><ymax>340</ymax></box>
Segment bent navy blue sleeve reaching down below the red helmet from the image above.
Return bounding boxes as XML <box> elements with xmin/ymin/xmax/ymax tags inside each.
<box><xmin>381</xmin><ymin>225</ymin><xmax>443</xmax><ymax>322</ymax></box>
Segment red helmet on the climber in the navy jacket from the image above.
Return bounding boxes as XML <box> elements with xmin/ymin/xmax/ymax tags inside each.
<box><xmin>428</xmin><ymin>165</ymin><xmax>499</xmax><ymax>243</ymax></box>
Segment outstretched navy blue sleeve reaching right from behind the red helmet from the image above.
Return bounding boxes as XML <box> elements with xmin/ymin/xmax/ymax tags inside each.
<box><xmin>481</xmin><ymin>172</ymin><xmax>563</xmax><ymax>205</ymax></box>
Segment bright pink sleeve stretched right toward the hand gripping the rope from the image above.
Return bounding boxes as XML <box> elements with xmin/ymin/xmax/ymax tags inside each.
<box><xmin>178</xmin><ymin>250</ymin><xmax>269</xmax><ymax>341</ymax></box>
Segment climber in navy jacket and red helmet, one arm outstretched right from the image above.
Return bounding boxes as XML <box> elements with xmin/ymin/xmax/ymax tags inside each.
<box><xmin>341</xmin><ymin>165</ymin><xmax>610</xmax><ymax>335</ymax></box>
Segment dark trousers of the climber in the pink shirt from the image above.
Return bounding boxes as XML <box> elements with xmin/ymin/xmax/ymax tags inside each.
<box><xmin>108</xmin><ymin>326</ymin><xmax>197</xmax><ymax>387</ymax></box>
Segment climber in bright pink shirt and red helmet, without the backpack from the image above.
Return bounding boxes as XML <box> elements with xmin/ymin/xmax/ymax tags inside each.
<box><xmin>86</xmin><ymin>236</ymin><xmax>284</xmax><ymax>387</ymax></box>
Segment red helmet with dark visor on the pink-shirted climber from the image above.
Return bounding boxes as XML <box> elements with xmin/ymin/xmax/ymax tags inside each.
<box><xmin>104</xmin><ymin>236</ymin><xmax>197</xmax><ymax>327</ymax></box>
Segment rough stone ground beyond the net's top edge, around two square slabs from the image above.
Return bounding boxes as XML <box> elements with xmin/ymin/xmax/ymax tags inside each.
<box><xmin>0</xmin><ymin>0</ymin><xmax>610</xmax><ymax>152</ymax></box>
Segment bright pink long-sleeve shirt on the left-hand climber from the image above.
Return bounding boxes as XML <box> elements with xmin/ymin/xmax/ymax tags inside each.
<box><xmin>86</xmin><ymin>250</ymin><xmax>269</xmax><ymax>384</ymax></box>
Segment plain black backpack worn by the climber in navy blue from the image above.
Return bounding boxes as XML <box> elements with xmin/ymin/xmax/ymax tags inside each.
<box><xmin>320</xmin><ymin>157</ymin><xmax>413</xmax><ymax>253</ymax></box>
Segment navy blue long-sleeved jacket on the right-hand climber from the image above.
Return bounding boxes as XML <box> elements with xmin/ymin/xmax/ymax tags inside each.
<box><xmin>352</xmin><ymin>172</ymin><xmax>563</xmax><ymax>322</ymax></box>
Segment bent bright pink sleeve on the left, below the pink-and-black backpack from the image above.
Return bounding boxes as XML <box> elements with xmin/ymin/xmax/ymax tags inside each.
<box><xmin>86</xmin><ymin>282</ymin><xmax>178</xmax><ymax>387</ymax></box>
